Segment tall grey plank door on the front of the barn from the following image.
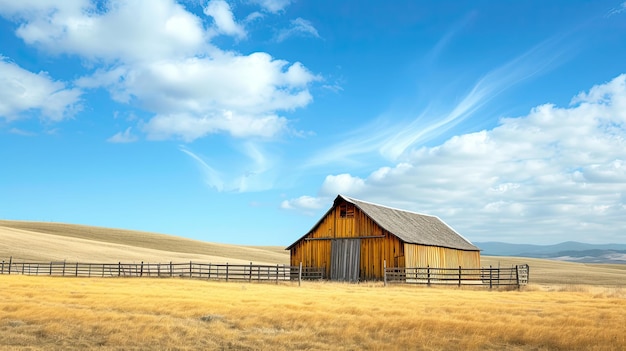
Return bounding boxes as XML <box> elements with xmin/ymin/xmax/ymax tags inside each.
<box><xmin>330</xmin><ymin>239</ymin><xmax>361</xmax><ymax>282</ymax></box>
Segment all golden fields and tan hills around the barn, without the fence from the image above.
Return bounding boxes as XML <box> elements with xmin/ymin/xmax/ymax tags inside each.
<box><xmin>0</xmin><ymin>221</ymin><xmax>626</xmax><ymax>350</ymax></box>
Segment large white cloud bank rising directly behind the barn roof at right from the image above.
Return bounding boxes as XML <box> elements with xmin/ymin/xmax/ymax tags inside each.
<box><xmin>283</xmin><ymin>75</ymin><xmax>626</xmax><ymax>243</ymax></box>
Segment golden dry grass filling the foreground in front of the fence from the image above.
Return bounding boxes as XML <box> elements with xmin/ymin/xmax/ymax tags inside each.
<box><xmin>0</xmin><ymin>275</ymin><xmax>626</xmax><ymax>350</ymax></box>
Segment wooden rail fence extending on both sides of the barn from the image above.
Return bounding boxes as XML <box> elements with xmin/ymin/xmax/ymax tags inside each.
<box><xmin>0</xmin><ymin>258</ymin><xmax>530</xmax><ymax>289</ymax></box>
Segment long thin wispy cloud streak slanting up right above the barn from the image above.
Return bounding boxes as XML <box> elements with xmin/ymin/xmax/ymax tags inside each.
<box><xmin>306</xmin><ymin>32</ymin><xmax>567</xmax><ymax>166</ymax></box>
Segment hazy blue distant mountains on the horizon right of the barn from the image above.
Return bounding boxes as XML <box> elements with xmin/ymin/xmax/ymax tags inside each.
<box><xmin>474</xmin><ymin>241</ymin><xmax>626</xmax><ymax>264</ymax></box>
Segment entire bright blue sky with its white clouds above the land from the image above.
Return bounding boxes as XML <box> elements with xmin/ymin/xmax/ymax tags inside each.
<box><xmin>0</xmin><ymin>0</ymin><xmax>626</xmax><ymax>246</ymax></box>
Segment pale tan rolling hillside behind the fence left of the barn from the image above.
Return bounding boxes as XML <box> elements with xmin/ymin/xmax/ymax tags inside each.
<box><xmin>0</xmin><ymin>220</ymin><xmax>289</xmax><ymax>264</ymax></box>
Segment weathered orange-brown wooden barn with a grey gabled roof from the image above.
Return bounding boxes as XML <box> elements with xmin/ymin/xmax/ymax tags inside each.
<box><xmin>287</xmin><ymin>195</ymin><xmax>480</xmax><ymax>281</ymax></box>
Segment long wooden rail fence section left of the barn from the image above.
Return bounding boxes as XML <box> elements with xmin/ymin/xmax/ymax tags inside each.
<box><xmin>0</xmin><ymin>258</ymin><xmax>325</xmax><ymax>283</ymax></box>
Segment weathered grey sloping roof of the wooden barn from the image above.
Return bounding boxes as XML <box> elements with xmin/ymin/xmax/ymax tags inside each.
<box><xmin>342</xmin><ymin>195</ymin><xmax>480</xmax><ymax>251</ymax></box>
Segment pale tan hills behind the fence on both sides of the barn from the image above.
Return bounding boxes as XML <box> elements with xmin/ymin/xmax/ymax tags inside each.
<box><xmin>0</xmin><ymin>220</ymin><xmax>626</xmax><ymax>286</ymax></box>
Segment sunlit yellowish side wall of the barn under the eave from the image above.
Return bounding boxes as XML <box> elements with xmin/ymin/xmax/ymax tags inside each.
<box><xmin>404</xmin><ymin>243</ymin><xmax>480</xmax><ymax>268</ymax></box>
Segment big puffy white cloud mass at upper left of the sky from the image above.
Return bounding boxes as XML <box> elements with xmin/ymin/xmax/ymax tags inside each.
<box><xmin>0</xmin><ymin>0</ymin><xmax>319</xmax><ymax>141</ymax></box>
